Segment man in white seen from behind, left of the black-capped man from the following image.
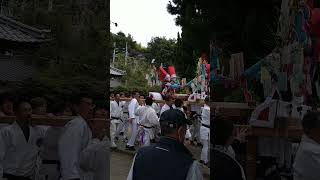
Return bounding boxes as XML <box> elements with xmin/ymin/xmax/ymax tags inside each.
<box><xmin>137</xmin><ymin>97</ymin><xmax>160</xmax><ymax>146</ymax></box>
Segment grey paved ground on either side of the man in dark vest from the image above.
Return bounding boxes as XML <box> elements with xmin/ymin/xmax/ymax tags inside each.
<box><xmin>110</xmin><ymin>136</ymin><xmax>210</xmax><ymax>180</ymax></box>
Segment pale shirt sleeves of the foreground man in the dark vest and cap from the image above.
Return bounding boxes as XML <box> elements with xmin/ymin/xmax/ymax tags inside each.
<box><xmin>127</xmin><ymin>156</ymin><xmax>203</xmax><ymax>180</ymax></box>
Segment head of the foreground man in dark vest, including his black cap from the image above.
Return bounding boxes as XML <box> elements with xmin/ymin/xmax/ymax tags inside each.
<box><xmin>160</xmin><ymin>109</ymin><xmax>192</xmax><ymax>143</ymax></box>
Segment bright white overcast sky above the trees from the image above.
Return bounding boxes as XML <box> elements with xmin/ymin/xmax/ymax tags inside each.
<box><xmin>110</xmin><ymin>0</ymin><xmax>181</xmax><ymax>47</ymax></box>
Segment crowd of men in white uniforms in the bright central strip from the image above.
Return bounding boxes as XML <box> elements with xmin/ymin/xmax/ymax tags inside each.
<box><xmin>110</xmin><ymin>92</ymin><xmax>210</xmax><ymax>179</ymax></box>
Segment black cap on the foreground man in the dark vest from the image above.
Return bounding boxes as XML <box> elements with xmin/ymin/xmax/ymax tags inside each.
<box><xmin>160</xmin><ymin>109</ymin><xmax>192</xmax><ymax>128</ymax></box>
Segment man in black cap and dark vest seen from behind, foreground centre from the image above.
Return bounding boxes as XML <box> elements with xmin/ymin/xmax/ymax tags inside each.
<box><xmin>127</xmin><ymin>109</ymin><xmax>203</xmax><ymax>180</ymax></box>
